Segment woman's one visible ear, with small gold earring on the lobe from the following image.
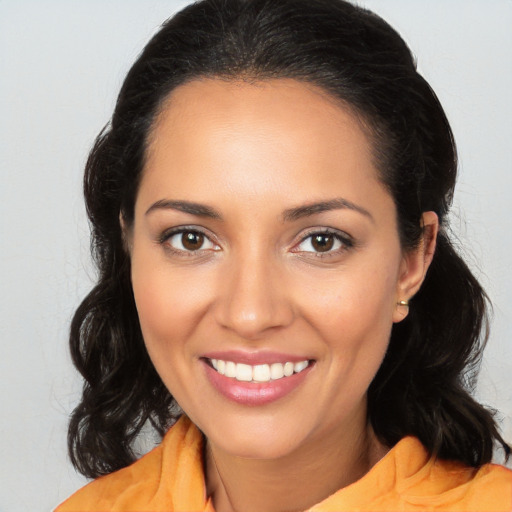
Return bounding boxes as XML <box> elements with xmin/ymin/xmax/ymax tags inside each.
<box><xmin>393</xmin><ymin>212</ymin><xmax>439</xmax><ymax>322</ymax></box>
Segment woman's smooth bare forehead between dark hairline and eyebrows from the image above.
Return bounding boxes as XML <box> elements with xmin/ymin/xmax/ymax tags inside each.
<box><xmin>141</xmin><ymin>79</ymin><xmax>386</xmax><ymax>216</ymax></box>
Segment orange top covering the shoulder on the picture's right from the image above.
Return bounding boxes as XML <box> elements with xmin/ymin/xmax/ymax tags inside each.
<box><xmin>312</xmin><ymin>437</ymin><xmax>512</xmax><ymax>512</ymax></box>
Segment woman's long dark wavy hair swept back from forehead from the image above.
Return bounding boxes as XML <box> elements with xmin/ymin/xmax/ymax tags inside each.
<box><xmin>68</xmin><ymin>0</ymin><xmax>510</xmax><ymax>477</ymax></box>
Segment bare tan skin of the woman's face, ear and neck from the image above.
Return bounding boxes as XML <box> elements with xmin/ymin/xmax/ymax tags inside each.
<box><xmin>125</xmin><ymin>79</ymin><xmax>437</xmax><ymax>512</ymax></box>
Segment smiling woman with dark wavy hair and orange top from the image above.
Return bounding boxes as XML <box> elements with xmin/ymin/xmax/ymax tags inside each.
<box><xmin>57</xmin><ymin>0</ymin><xmax>512</xmax><ymax>512</ymax></box>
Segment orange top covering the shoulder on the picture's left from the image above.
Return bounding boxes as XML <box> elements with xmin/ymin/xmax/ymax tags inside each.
<box><xmin>55</xmin><ymin>418</ymin><xmax>206</xmax><ymax>512</ymax></box>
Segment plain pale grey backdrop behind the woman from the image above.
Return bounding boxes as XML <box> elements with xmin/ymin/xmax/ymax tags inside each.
<box><xmin>0</xmin><ymin>0</ymin><xmax>512</xmax><ymax>512</ymax></box>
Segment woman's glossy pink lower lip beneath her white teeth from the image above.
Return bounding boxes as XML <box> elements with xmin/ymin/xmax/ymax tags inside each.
<box><xmin>204</xmin><ymin>362</ymin><xmax>313</xmax><ymax>406</ymax></box>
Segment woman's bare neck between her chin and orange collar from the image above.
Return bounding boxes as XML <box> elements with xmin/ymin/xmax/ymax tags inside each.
<box><xmin>206</xmin><ymin>416</ymin><xmax>386</xmax><ymax>512</ymax></box>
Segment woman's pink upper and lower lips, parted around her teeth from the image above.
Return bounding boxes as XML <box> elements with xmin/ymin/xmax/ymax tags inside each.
<box><xmin>203</xmin><ymin>351</ymin><xmax>313</xmax><ymax>406</ymax></box>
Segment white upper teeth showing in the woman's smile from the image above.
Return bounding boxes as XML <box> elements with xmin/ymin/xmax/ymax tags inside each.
<box><xmin>205</xmin><ymin>358</ymin><xmax>314</xmax><ymax>382</ymax></box>
